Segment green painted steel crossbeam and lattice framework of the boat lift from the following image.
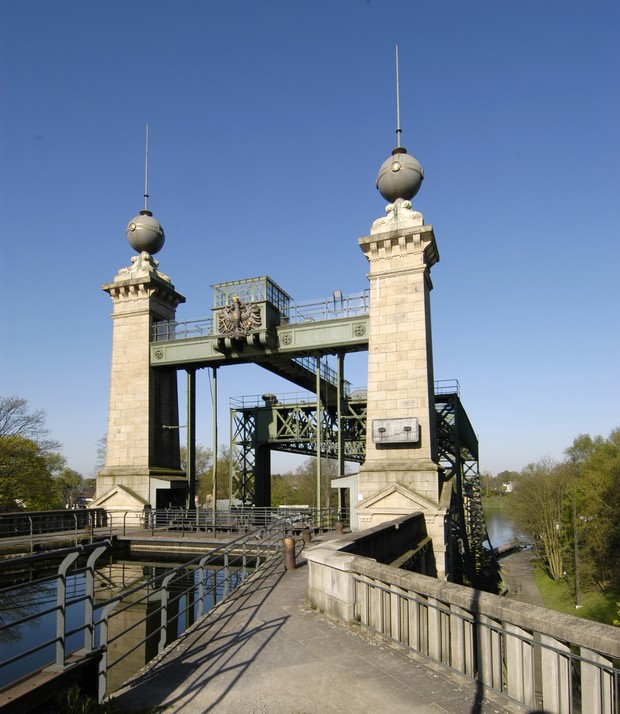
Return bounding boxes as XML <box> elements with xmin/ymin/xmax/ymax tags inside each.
<box><xmin>145</xmin><ymin>277</ymin><xmax>491</xmax><ymax>583</ymax></box>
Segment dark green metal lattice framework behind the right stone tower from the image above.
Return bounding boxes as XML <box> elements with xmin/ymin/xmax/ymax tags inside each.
<box><xmin>231</xmin><ymin>387</ymin><xmax>497</xmax><ymax>584</ymax></box>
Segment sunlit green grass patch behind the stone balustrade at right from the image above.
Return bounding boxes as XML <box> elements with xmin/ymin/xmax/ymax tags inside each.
<box><xmin>534</xmin><ymin>567</ymin><xmax>620</xmax><ymax>625</ymax></box>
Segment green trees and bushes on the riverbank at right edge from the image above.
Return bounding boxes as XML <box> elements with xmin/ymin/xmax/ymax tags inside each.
<box><xmin>481</xmin><ymin>429</ymin><xmax>620</xmax><ymax>625</ymax></box>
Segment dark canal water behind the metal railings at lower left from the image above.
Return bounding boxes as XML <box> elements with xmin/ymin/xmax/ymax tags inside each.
<box><xmin>0</xmin><ymin>557</ymin><xmax>249</xmax><ymax>694</ymax></box>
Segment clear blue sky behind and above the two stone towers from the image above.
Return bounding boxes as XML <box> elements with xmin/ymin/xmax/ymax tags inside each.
<box><xmin>0</xmin><ymin>0</ymin><xmax>620</xmax><ymax>475</ymax></box>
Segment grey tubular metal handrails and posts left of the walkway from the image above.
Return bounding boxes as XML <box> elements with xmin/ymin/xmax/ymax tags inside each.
<box><xmin>0</xmin><ymin>509</ymin><xmax>302</xmax><ymax>699</ymax></box>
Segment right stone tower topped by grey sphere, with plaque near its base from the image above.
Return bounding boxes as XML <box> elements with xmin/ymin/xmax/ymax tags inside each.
<box><xmin>357</xmin><ymin>140</ymin><xmax>450</xmax><ymax>577</ymax></box>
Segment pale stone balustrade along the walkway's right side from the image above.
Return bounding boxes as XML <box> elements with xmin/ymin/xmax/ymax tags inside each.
<box><xmin>304</xmin><ymin>517</ymin><xmax>620</xmax><ymax>714</ymax></box>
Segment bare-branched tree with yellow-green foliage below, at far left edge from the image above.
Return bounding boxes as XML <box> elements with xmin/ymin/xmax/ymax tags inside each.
<box><xmin>0</xmin><ymin>397</ymin><xmax>65</xmax><ymax>511</ymax></box>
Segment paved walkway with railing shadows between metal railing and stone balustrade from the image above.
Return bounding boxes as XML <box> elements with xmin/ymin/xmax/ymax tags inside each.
<box><xmin>116</xmin><ymin>540</ymin><xmax>512</xmax><ymax>714</ymax></box>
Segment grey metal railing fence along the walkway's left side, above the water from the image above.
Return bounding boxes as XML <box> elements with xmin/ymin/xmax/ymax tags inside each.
<box><xmin>0</xmin><ymin>517</ymin><xmax>293</xmax><ymax>700</ymax></box>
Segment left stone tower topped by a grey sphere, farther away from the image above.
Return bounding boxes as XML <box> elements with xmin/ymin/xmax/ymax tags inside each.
<box><xmin>93</xmin><ymin>159</ymin><xmax>187</xmax><ymax>510</ymax></box>
